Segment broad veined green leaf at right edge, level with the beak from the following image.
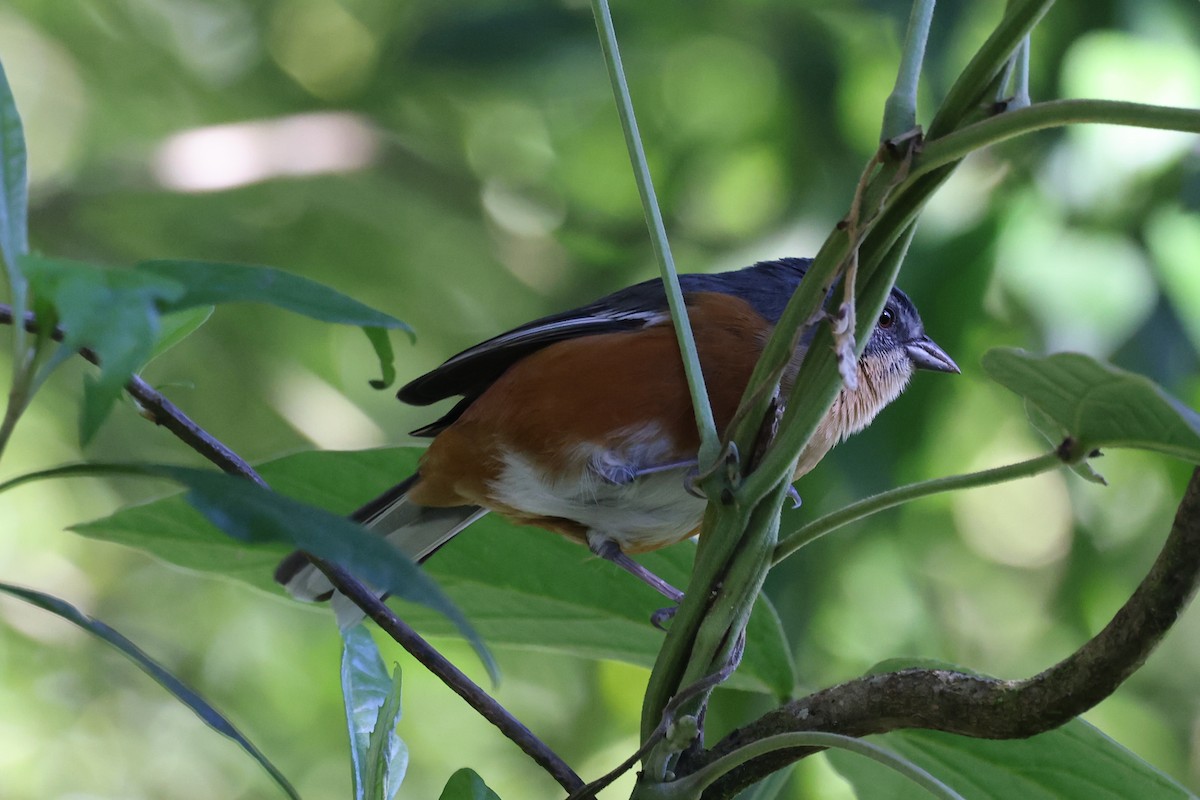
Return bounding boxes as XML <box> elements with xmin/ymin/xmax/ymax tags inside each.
<box><xmin>983</xmin><ymin>348</ymin><xmax>1200</xmax><ymax>463</ymax></box>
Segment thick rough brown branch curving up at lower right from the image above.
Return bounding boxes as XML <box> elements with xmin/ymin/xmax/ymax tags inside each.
<box><xmin>688</xmin><ymin>468</ymin><xmax>1200</xmax><ymax>800</ymax></box>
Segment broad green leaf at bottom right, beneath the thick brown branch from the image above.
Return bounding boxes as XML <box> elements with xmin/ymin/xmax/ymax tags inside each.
<box><xmin>828</xmin><ymin>720</ymin><xmax>1195</xmax><ymax>800</ymax></box>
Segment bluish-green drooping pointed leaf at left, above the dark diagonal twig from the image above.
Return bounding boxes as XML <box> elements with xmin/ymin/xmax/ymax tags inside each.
<box><xmin>20</xmin><ymin>255</ymin><xmax>185</xmax><ymax>444</ymax></box>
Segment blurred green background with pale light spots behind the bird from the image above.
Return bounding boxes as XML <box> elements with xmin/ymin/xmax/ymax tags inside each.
<box><xmin>0</xmin><ymin>0</ymin><xmax>1200</xmax><ymax>800</ymax></box>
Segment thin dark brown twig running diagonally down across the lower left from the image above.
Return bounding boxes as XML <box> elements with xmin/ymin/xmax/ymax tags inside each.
<box><xmin>0</xmin><ymin>303</ymin><xmax>583</xmax><ymax>792</ymax></box>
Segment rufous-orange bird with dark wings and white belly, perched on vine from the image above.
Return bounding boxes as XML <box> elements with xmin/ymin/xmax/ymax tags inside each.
<box><xmin>275</xmin><ymin>258</ymin><xmax>959</xmax><ymax>601</ymax></box>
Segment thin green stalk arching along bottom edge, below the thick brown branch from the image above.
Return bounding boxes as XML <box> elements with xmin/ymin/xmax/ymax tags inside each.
<box><xmin>643</xmin><ymin>730</ymin><xmax>962</xmax><ymax>800</ymax></box>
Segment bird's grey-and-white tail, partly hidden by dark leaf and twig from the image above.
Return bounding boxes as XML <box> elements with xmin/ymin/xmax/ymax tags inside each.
<box><xmin>275</xmin><ymin>475</ymin><xmax>487</xmax><ymax>601</ymax></box>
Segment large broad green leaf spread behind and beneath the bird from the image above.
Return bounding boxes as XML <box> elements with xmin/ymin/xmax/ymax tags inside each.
<box><xmin>74</xmin><ymin>447</ymin><xmax>796</xmax><ymax>697</ymax></box>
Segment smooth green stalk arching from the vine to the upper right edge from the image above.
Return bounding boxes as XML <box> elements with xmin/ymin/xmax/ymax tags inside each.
<box><xmin>912</xmin><ymin>100</ymin><xmax>1200</xmax><ymax>178</ymax></box>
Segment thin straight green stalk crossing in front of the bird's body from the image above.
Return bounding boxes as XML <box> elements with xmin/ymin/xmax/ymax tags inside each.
<box><xmin>592</xmin><ymin>0</ymin><xmax>720</xmax><ymax>471</ymax></box>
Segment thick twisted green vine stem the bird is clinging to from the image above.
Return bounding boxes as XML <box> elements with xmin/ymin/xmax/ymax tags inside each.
<box><xmin>642</xmin><ymin>0</ymin><xmax>1050</xmax><ymax>767</ymax></box>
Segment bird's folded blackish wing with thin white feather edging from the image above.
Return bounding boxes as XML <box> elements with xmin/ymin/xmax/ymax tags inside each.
<box><xmin>397</xmin><ymin>259</ymin><xmax>809</xmax><ymax>437</ymax></box>
